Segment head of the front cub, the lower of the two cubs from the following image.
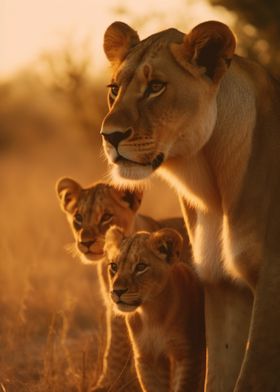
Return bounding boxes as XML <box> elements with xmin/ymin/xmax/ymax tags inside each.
<box><xmin>105</xmin><ymin>226</ymin><xmax>183</xmax><ymax>312</ymax></box>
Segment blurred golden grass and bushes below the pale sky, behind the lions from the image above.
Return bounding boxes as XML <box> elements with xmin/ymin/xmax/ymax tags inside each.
<box><xmin>0</xmin><ymin>50</ymin><xmax>178</xmax><ymax>392</ymax></box>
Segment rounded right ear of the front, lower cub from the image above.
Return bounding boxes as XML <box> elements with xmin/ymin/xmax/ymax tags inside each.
<box><xmin>150</xmin><ymin>229</ymin><xmax>183</xmax><ymax>263</ymax></box>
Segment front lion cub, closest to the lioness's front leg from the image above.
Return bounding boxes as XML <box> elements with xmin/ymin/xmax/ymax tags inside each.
<box><xmin>105</xmin><ymin>227</ymin><xmax>205</xmax><ymax>392</ymax></box>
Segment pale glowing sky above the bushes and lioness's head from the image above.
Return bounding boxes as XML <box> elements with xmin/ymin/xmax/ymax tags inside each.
<box><xmin>0</xmin><ymin>0</ymin><xmax>234</xmax><ymax>76</ymax></box>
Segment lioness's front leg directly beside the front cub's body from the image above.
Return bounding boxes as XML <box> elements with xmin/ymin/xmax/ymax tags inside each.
<box><xmin>205</xmin><ymin>282</ymin><xmax>252</xmax><ymax>392</ymax></box>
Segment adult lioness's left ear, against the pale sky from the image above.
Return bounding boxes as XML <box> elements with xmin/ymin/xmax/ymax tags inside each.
<box><xmin>103</xmin><ymin>22</ymin><xmax>140</xmax><ymax>64</ymax></box>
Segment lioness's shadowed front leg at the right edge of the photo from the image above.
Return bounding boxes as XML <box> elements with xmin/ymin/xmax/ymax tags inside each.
<box><xmin>234</xmin><ymin>256</ymin><xmax>280</xmax><ymax>392</ymax></box>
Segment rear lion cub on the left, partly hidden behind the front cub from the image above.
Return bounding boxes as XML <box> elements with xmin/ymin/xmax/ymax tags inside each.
<box><xmin>56</xmin><ymin>178</ymin><xmax>189</xmax><ymax>392</ymax></box>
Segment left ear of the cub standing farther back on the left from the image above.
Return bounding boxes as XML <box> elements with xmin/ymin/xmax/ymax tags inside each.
<box><xmin>56</xmin><ymin>178</ymin><xmax>82</xmax><ymax>213</ymax></box>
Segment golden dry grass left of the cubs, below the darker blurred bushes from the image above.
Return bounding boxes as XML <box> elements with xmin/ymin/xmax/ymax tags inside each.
<box><xmin>0</xmin><ymin>152</ymin><xmax>107</xmax><ymax>391</ymax></box>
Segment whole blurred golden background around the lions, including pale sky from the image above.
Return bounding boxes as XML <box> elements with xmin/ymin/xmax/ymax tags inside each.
<box><xmin>0</xmin><ymin>0</ymin><xmax>280</xmax><ymax>392</ymax></box>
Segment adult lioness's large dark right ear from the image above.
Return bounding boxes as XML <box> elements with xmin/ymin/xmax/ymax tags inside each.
<box><xmin>171</xmin><ymin>21</ymin><xmax>236</xmax><ymax>82</ymax></box>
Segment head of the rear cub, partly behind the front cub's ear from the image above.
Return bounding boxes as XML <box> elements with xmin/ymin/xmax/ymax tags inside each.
<box><xmin>56</xmin><ymin>178</ymin><xmax>142</xmax><ymax>263</ymax></box>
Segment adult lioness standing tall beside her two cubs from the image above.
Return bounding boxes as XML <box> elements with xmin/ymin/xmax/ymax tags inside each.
<box><xmin>99</xmin><ymin>21</ymin><xmax>280</xmax><ymax>392</ymax></box>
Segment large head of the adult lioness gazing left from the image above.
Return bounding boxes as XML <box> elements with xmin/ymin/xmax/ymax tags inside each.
<box><xmin>101</xmin><ymin>21</ymin><xmax>235</xmax><ymax>183</ymax></box>
